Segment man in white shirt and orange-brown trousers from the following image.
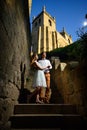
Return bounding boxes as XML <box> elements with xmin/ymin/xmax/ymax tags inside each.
<box><xmin>38</xmin><ymin>52</ymin><xmax>52</xmax><ymax>103</ymax></box>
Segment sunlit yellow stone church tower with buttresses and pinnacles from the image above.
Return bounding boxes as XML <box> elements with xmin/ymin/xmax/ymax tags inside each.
<box><xmin>31</xmin><ymin>7</ymin><xmax>72</xmax><ymax>54</ymax></box>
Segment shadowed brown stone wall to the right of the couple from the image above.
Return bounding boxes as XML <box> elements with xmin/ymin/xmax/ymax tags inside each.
<box><xmin>51</xmin><ymin>58</ymin><xmax>87</xmax><ymax>116</ymax></box>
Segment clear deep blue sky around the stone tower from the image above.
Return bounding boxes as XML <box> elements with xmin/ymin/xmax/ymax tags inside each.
<box><xmin>30</xmin><ymin>0</ymin><xmax>87</xmax><ymax>42</ymax></box>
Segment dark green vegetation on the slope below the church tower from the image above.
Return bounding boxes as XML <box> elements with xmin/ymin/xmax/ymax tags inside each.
<box><xmin>47</xmin><ymin>33</ymin><xmax>87</xmax><ymax>61</ymax></box>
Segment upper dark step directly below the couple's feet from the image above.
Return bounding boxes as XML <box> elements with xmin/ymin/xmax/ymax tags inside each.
<box><xmin>14</xmin><ymin>104</ymin><xmax>77</xmax><ymax>114</ymax></box>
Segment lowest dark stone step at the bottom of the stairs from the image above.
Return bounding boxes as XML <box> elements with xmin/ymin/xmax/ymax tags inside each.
<box><xmin>10</xmin><ymin>114</ymin><xmax>87</xmax><ymax>130</ymax></box>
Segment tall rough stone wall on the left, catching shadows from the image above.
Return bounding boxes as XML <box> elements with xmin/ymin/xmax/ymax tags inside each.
<box><xmin>0</xmin><ymin>0</ymin><xmax>30</xmax><ymax>128</ymax></box>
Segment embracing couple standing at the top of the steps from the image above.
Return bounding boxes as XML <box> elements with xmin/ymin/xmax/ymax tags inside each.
<box><xmin>31</xmin><ymin>52</ymin><xmax>52</xmax><ymax>103</ymax></box>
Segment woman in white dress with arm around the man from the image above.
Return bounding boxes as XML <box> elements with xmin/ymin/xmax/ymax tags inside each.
<box><xmin>31</xmin><ymin>54</ymin><xmax>49</xmax><ymax>103</ymax></box>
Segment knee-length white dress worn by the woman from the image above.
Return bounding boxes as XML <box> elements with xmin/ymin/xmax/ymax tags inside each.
<box><xmin>33</xmin><ymin>61</ymin><xmax>47</xmax><ymax>87</ymax></box>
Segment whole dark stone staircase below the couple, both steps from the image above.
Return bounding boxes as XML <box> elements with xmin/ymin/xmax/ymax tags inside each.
<box><xmin>10</xmin><ymin>104</ymin><xmax>87</xmax><ymax>130</ymax></box>
